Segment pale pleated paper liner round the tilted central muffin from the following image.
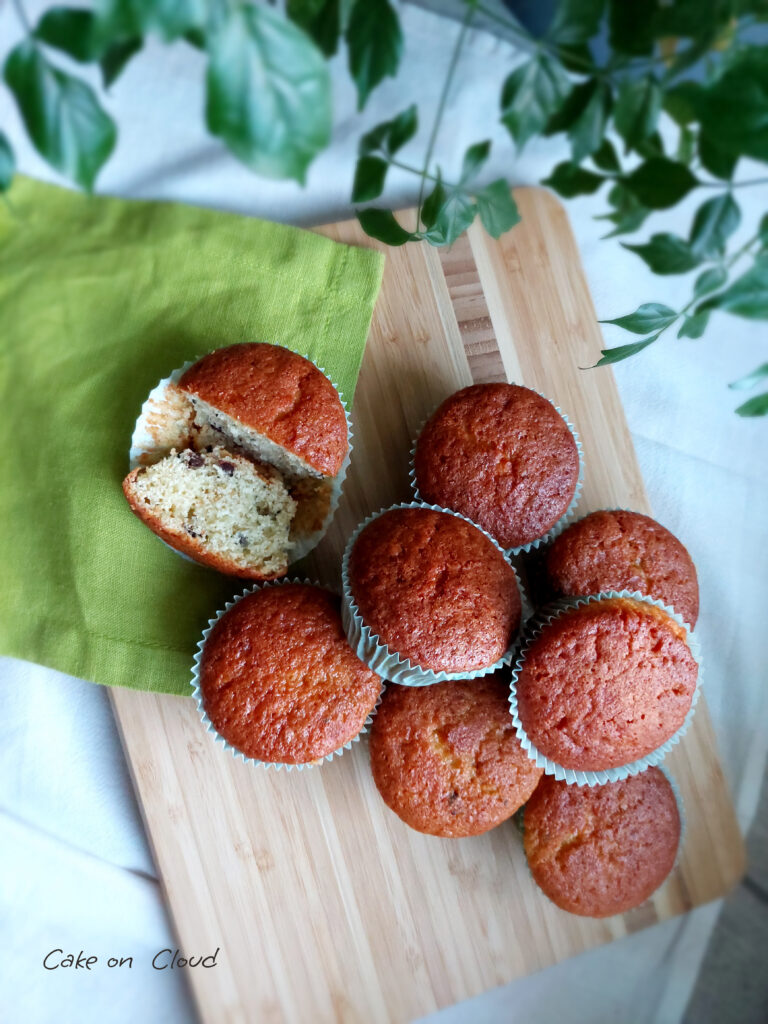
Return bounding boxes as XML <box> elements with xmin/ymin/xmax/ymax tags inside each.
<box><xmin>341</xmin><ymin>502</ymin><xmax>532</xmax><ymax>686</ymax></box>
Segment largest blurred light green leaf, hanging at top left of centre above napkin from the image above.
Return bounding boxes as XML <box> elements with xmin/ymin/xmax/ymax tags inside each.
<box><xmin>206</xmin><ymin>5</ymin><xmax>331</xmax><ymax>183</ymax></box>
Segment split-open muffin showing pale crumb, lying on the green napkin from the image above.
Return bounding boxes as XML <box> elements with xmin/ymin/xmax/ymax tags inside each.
<box><xmin>123</xmin><ymin>343</ymin><xmax>349</xmax><ymax>580</ymax></box>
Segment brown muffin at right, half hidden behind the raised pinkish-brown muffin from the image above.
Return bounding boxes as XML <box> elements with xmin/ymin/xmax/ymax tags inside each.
<box><xmin>546</xmin><ymin>510</ymin><xmax>698</xmax><ymax>627</ymax></box>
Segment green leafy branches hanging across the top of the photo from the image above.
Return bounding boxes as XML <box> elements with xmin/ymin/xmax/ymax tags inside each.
<box><xmin>0</xmin><ymin>0</ymin><xmax>768</xmax><ymax>416</ymax></box>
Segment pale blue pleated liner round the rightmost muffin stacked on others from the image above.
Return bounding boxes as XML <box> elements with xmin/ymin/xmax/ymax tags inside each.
<box><xmin>509</xmin><ymin>590</ymin><xmax>701</xmax><ymax>785</ymax></box>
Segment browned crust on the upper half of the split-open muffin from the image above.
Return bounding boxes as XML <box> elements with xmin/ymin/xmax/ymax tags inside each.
<box><xmin>179</xmin><ymin>342</ymin><xmax>348</xmax><ymax>476</ymax></box>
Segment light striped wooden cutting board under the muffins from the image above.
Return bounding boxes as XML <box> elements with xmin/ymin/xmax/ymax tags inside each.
<box><xmin>112</xmin><ymin>188</ymin><xmax>744</xmax><ymax>1024</ymax></box>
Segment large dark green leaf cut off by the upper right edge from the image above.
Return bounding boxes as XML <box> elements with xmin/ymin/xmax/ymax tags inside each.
<box><xmin>698</xmin><ymin>45</ymin><xmax>768</xmax><ymax>161</ymax></box>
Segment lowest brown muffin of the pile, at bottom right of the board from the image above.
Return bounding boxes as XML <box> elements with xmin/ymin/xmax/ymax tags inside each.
<box><xmin>523</xmin><ymin>768</ymin><xmax>681</xmax><ymax>918</ymax></box>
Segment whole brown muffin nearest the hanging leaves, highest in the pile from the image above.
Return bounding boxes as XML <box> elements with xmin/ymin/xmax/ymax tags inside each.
<box><xmin>414</xmin><ymin>384</ymin><xmax>580</xmax><ymax>550</ymax></box>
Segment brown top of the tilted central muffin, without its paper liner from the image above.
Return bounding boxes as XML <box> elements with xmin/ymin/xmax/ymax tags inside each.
<box><xmin>349</xmin><ymin>508</ymin><xmax>522</xmax><ymax>672</ymax></box>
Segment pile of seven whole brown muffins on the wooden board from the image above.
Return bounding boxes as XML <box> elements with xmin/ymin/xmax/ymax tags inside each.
<box><xmin>123</xmin><ymin>346</ymin><xmax>698</xmax><ymax>916</ymax></box>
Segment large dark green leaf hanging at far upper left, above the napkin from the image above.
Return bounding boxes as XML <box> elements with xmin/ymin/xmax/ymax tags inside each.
<box><xmin>5</xmin><ymin>40</ymin><xmax>117</xmax><ymax>190</ymax></box>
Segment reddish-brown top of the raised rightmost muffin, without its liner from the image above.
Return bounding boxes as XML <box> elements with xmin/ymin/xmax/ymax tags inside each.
<box><xmin>516</xmin><ymin>598</ymin><xmax>698</xmax><ymax>771</ymax></box>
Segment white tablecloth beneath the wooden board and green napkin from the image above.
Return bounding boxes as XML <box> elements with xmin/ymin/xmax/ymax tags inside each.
<box><xmin>0</xmin><ymin>2</ymin><xmax>768</xmax><ymax>1024</ymax></box>
